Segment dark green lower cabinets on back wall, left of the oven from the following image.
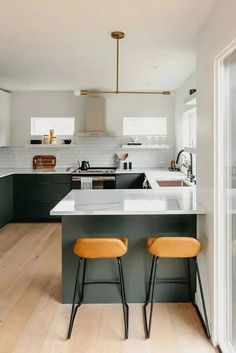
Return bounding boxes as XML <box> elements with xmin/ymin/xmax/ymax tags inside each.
<box><xmin>14</xmin><ymin>174</ymin><xmax>71</xmax><ymax>221</ymax></box>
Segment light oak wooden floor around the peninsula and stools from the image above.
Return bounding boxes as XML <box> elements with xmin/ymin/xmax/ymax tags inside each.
<box><xmin>0</xmin><ymin>223</ymin><xmax>216</xmax><ymax>353</ymax></box>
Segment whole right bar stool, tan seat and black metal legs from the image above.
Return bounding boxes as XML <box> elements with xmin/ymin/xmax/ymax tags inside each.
<box><xmin>144</xmin><ymin>237</ymin><xmax>210</xmax><ymax>338</ymax></box>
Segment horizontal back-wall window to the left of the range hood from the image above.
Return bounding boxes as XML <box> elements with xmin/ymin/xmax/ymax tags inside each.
<box><xmin>31</xmin><ymin>117</ymin><xmax>75</xmax><ymax>136</ymax></box>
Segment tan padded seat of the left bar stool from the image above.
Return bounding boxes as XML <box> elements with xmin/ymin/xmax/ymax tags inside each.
<box><xmin>73</xmin><ymin>237</ymin><xmax>128</xmax><ymax>259</ymax></box>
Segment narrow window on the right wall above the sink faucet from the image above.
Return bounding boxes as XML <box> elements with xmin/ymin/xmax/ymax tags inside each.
<box><xmin>183</xmin><ymin>107</ymin><xmax>197</xmax><ymax>148</ymax></box>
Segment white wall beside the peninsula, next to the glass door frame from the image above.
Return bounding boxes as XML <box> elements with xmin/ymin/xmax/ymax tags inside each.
<box><xmin>197</xmin><ymin>0</ymin><xmax>236</xmax><ymax>339</ymax></box>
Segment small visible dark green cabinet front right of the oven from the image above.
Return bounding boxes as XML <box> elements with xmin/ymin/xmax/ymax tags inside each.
<box><xmin>116</xmin><ymin>173</ymin><xmax>145</xmax><ymax>189</ymax></box>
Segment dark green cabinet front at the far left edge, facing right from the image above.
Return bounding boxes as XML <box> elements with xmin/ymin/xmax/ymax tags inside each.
<box><xmin>0</xmin><ymin>175</ymin><xmax>13</xmax><ymax>228</ymax></box>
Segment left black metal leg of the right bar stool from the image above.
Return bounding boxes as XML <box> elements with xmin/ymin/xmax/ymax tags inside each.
<box><xmin>144</xmin><ymin>256</ymin><xmax>159</xmax><ymax>338</ymax></box>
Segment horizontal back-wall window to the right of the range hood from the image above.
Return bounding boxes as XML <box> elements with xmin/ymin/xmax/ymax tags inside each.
<box><xmin>123</xmin><ymin>117</ymin><xmax>167</xmax><ymax>136</ymax></box>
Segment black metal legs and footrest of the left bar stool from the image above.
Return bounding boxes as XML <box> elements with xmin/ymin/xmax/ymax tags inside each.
<box><xmin>67</xmin><ymin>257</ymin><xmax>129</xmax><ymax>339</ymax></box>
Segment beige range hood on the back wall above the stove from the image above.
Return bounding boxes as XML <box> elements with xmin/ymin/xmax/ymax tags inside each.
<box><xmin>79</xmin><ymin>96</ymin><xmax>113</xmax><ymax>136</ymax></box>
